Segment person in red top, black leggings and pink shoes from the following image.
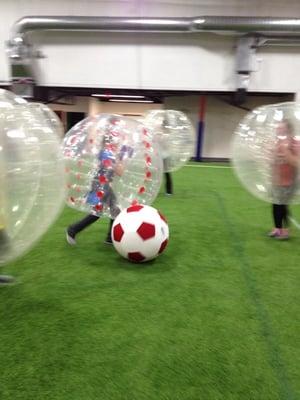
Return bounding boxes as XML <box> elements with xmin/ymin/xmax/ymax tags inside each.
<box><xmin>269</xmin><ymin>119</ymin><xmax>300</xmax><ymax>239</ymax></box>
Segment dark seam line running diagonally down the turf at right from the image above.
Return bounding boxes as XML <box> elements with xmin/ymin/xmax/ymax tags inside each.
<box><xmin>212</xmin><ymin>191</ymin><xmax>296</xmax><ymax>400</ymax></box>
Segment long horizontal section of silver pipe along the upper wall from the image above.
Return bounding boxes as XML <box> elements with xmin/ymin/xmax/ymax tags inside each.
<box><xmin>11</xmin><ymin>16</ymin><xmax>300</xmax><ymax>40</ymax></box>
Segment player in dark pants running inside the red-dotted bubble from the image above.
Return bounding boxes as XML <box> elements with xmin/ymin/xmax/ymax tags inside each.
<box><xmin>66</xmin><ymin>134</ymin><xmax>129</xmax><ymax>245</ymax></box>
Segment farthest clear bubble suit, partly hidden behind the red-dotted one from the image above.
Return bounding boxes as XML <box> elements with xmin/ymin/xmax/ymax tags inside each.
<box><xmin>144</xmin><ymin>110</ymin><xmax>196</xmax><ymax>172</ymax></box>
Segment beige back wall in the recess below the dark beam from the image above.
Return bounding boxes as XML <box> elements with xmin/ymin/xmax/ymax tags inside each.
<box><xmin>49</xmin><ymin>95</ymin><xmax>291</xmax><ymax>158</ymax></box>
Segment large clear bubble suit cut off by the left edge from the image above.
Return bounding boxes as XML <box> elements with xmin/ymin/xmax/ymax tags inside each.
<box><xmin>0</xmin><ymin>90</ymin><xmax>65</xmax><ymax>264</ymax></box>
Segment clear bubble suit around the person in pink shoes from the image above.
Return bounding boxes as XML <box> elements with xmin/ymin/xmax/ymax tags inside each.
<box><xmin>232</xmin><ymin>102</ymin><xmax>300</xmax><ymax>204</ymax></box>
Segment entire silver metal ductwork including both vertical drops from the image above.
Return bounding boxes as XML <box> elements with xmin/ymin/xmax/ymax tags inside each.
<box><xmin>7</xmin><ymin>16</ymin><xmax>300</xmax><ymax>98</ymax></box>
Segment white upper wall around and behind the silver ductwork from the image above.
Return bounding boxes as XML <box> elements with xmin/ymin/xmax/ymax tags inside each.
<box><xmin>0</xmin><ymin>0</ymin><xmax>300</xmax><ymax>92</ymax></box>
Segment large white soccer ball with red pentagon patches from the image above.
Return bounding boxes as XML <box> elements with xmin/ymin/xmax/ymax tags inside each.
<box><xmin>112</xmin><ymin>204</ymin><xmax>169</xmax><ymax>262</ymax></box>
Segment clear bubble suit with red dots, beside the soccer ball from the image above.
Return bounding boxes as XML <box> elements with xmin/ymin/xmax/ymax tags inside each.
<box><xmin>64</xmin><ymin>114</ymin><xmax>163</xmax><ymax>218</ymax></box>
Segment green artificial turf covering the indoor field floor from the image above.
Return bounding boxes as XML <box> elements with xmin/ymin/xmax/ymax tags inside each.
<box><xmin>0</xmin><ymin>164</ymin><xmax>300</xmax><ymax>400</ymax></box>
